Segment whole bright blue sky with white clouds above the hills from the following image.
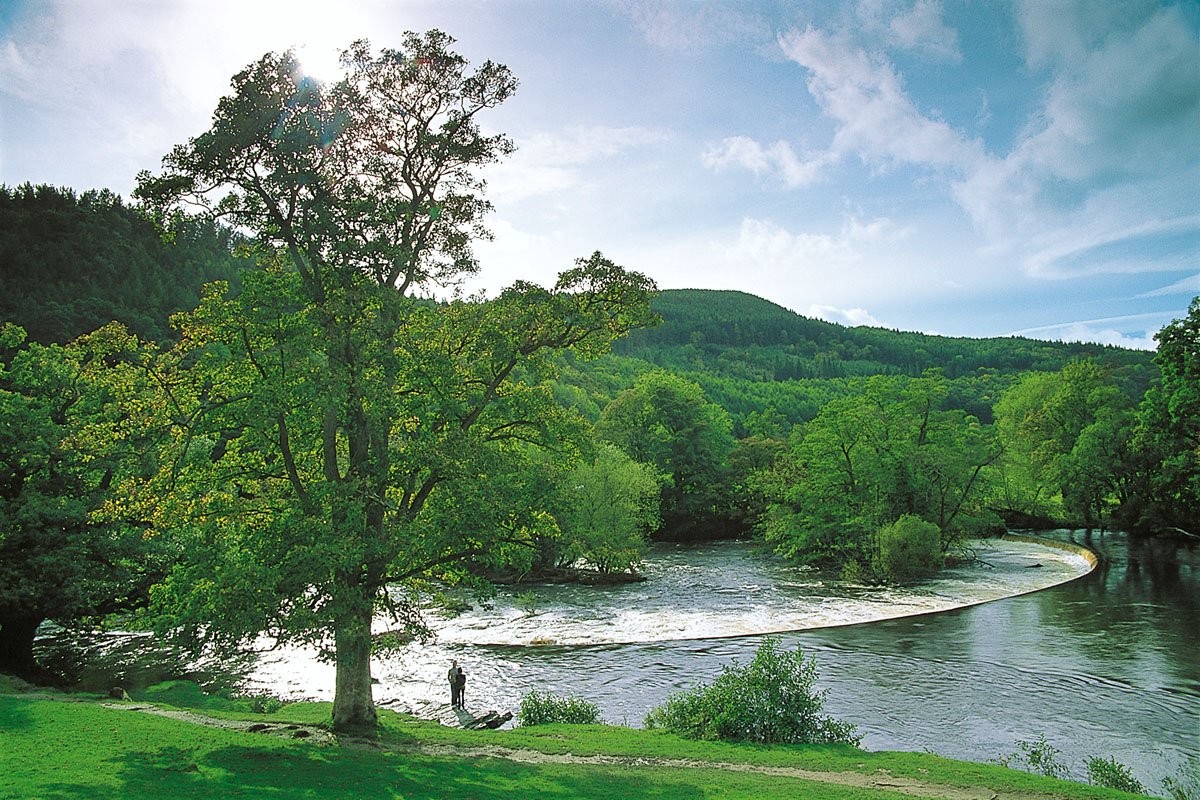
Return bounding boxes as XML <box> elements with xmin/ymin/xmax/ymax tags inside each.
<box><xmin>0</xmin><ymin>0</ymin><xmax>1200</xmax><ymax>349</ymax></box>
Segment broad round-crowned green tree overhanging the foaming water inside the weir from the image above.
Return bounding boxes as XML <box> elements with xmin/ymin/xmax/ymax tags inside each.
<box><xmin>758</xmin><ymin>373</ymin><xmax>1000</xmax><ymax>569</ymax></box>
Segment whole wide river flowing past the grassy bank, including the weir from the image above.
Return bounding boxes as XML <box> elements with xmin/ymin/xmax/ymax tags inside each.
<box><xmin>43</xmin><ymin>531</ymin><xmax>1200</xmax><ymax>793</ymax></box>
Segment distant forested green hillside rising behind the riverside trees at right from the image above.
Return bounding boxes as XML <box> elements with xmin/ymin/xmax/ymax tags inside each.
<box><xmin>556</xmin><ymin>289</ymin><xmax>1157</xmax><ymax>437</ymax></box>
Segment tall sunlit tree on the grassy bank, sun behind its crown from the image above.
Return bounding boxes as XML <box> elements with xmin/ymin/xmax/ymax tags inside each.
<box><xmin>125</xmin><ymin>31</ymin><xmax>653</xmax><ymax>730</ymax></box>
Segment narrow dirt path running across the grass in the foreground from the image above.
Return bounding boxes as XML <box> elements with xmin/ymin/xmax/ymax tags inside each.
<box><xmin>11</xmin><ymin>693</ymin><xmax>1080</xmax><ymax>800</ymax></box>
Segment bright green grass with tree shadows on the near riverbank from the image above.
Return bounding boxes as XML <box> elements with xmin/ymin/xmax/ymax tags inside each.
<box><xmin>0</xmin><ymin>684</ymin><xmax>1152</xmax><ymax>800</ymax></box>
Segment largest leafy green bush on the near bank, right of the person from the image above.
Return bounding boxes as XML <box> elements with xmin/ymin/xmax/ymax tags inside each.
<box><xmin>646</xmin><ymin>638</ymin><xmax>863</xmax><ymax>745</ymax></box>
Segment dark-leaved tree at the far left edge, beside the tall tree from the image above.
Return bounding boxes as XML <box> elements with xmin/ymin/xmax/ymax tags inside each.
<box><xmin>0</xmin><ymin>324</ymin><xmax>163</xmax><ymax>680</ymax></box>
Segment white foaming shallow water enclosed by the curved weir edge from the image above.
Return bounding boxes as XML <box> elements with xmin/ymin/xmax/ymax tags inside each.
<box><xmin>415</xmin><ymin>535</ymin><xmax>1096</xmax><ymax>646</ymax></box>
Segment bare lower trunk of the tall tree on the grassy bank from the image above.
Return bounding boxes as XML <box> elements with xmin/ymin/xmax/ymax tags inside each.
<box><xmin>334</xmin><ymin>588</ymin><xmax>376</xmax><ymax>733</ymax></box>
